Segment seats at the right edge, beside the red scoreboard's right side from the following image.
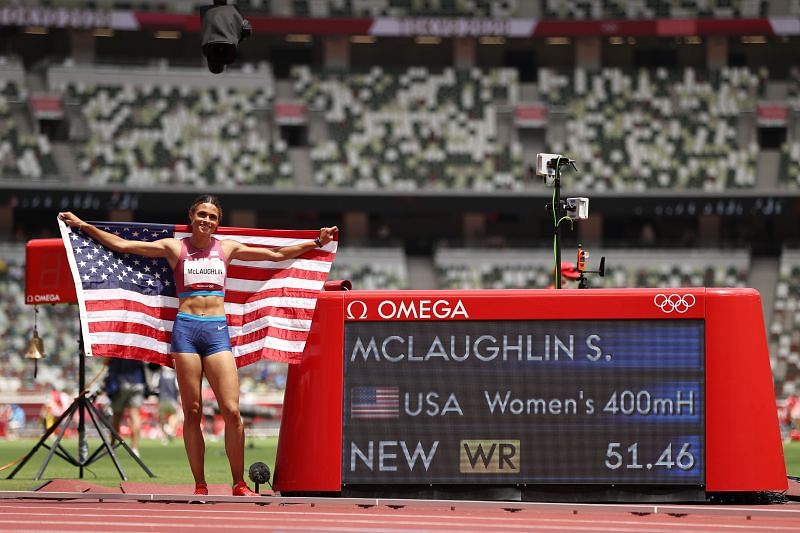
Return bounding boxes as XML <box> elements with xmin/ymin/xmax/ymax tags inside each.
<box><xmin>769</xmin><ymin>248</ymin><xmax>800</xmax><ymax>396</ymax></box>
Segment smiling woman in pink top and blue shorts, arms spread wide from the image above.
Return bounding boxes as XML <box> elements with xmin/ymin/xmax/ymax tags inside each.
<box><xmin>59</xmin><ymin>195</ymin><xmax>338</xmax><ymax>496</ymax></box>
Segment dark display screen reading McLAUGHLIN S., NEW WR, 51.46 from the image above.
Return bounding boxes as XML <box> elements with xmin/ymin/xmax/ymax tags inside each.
<box><xmin>342</xmin><ymin>319</ymin><xmax>705</xmax><ymax>486</ymax></box>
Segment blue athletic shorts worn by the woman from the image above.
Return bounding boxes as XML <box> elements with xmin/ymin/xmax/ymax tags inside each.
<box><xmin>170</xmin><ymin>312</ymin><xmax>231</xmax><ymax>356</ymax></box>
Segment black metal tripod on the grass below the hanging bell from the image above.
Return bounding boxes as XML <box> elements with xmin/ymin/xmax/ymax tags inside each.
<box><xmin>6</xmin><ymin>328</ymin><xmax>156</xmax><ymax>481</ymax></box>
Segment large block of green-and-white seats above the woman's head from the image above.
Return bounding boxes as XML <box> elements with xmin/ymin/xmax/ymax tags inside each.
<box><xmin>51</xmin><ymin>61</ymin><xmax>292</xmax><ymax>187</ymax></box>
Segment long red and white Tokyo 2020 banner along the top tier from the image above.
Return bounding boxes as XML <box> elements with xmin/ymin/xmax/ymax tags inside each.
<box><xmin>0</xmin><ymin>6</ymin><xmax>800</xmax><ymax>38</ymax></box>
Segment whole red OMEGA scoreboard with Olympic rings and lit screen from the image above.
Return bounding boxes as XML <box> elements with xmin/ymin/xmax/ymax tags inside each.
<box><xmin>275</xmin><ymin>288</ymin><xmax>787</xmax><ymax>500</ymax></box>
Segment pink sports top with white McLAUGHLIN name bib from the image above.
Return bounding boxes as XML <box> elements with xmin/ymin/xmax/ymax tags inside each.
<box><xmin>174</xmin><ymin>237</ymin><xmax>228</xmax><ymax>298</ymax></box>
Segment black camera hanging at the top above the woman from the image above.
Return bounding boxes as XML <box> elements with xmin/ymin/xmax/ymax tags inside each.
<box><xmin>200</xmin><ymin>0</ymin><xmax>253</xmax><ymax>74</ymax></box>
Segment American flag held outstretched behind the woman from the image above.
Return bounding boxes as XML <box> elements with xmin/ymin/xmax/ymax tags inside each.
<box><xmin>58</xmin><ymin>220</ymin><xmax>337</xmax><ymax>367</ymax></box>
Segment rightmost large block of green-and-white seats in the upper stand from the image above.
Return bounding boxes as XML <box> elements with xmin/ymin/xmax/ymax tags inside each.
<box><xmin>538</xmin><ymin>68</ymin><xmax>766</xmax><ymax>191</ymax></box>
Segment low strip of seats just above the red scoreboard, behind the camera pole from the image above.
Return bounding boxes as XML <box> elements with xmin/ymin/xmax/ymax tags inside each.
<box><xmin>434</xmin><ymin>248</ymin><xmax>750</xmax><ymax>289</ymax></box>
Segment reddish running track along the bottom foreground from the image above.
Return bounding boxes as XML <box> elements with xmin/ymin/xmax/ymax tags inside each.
<box><xmin>0</xmin><ymin>492</ymin><xmax>800</xmax><ymax>533</ymax></box>
